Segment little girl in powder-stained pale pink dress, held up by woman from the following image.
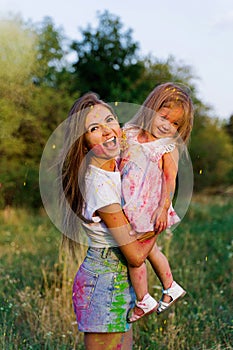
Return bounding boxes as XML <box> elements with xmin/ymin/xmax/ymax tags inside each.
<box><xmin>120</xmin><ymin>83</ymin><xmax>193</xmax><ymax>322</ymax></box>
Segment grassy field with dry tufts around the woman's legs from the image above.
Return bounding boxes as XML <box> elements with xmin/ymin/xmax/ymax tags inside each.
<box><xmin>0</xmin><ymin>196</ymin><xmax>233</xmax><ymax>350</ymax></box>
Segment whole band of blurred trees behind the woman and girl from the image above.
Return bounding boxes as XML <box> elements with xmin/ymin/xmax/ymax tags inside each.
<box><xmin>0</xmin><ymin>11</ymin><xmax>233</xmax><ymax>207</ymax></box>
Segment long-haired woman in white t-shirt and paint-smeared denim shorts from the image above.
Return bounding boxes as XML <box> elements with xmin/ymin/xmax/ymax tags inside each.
<box><xmin>61</xmin><ymin>93</ymin><xmax>157</xmax><ymax>350</ymax></box>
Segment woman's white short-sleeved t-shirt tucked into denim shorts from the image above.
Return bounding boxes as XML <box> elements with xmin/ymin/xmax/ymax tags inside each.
<box><xmin>83</xmin><ymin>165</ymin><xmax>121</xmax><ymax>248</ymax></box>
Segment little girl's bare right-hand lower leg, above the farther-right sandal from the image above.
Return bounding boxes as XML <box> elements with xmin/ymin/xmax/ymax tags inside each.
<box><xmin>148</xmin><ymin>243</ymin><xmax>173</xmax><ymax>303</ymax></box>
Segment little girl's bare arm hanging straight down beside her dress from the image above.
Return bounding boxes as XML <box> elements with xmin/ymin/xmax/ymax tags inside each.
<box><xmin>152</xmin><ymin>148</ymin><xmax>179</xmax><ymax>233</ymax></box>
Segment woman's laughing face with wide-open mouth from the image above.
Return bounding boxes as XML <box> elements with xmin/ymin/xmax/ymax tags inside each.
<box><xmin>85</xmin><ymin>104</ymin><xmax>121</xmax><ymax>159</ymax></box>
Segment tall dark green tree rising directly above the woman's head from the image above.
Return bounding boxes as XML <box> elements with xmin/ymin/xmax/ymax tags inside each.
<box><xmin>71</xmin><ymin>11</ymin><xmax>144</xmax><ymax>102</ymax></box>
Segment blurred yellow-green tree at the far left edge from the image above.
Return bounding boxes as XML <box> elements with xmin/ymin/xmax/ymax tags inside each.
<box><xmin>0</xmin><ymin>17</ymin><xmax>36</xmax><ymax>204</ymax></box>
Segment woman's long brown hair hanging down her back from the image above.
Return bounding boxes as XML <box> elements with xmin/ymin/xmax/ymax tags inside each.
<box><xmin>58</xmin><ymin>92</ymin><xmax>115</xmax><ymax>252</ymax></box>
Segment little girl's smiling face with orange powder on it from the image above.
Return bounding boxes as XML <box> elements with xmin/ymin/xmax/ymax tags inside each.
<box><xmin>151</xmin><ymin>106</ymin><xmax>184</xmax><ymax>139</ymax></box>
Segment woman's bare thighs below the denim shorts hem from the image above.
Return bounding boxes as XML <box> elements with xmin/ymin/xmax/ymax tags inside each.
<box><xmin>84</xmin><ymin>328</ymin><xmax>133</xmax><ymax>350</ymax></box>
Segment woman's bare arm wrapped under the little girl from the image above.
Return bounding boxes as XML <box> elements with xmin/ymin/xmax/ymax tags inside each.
<box><xmin>98</xmin><ymin>204</ymin><xmax>155</xmax><ymax>267</ymax></box>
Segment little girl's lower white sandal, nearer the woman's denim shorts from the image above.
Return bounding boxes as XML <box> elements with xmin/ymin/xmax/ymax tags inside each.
<box><xmin>127</xmin><ymin>293</ymin><xmax>158</xmax><ymax>323</ymax></box>
